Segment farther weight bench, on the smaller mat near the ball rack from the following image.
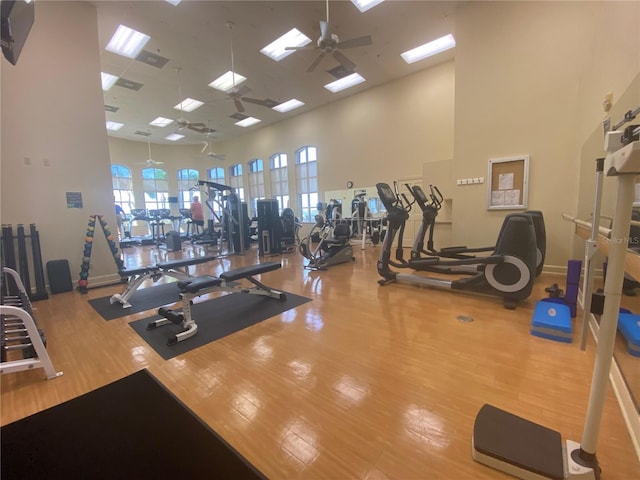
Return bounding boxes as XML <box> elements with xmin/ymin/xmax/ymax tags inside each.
<box><xmin>109</xmin><ymin>256</ymin><xmax>217</xmax><ymax>308</ymax></box>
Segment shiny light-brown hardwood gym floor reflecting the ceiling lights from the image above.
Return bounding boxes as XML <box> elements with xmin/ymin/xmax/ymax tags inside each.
<box><xmin>0</xmin><ymin>242</ymin><xmax>640</xmax><ymax>480</ymax></box>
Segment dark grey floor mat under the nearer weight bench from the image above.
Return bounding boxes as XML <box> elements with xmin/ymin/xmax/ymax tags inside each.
<box><xmin>129</xmin><ymin>293</ymin><xmax>311</xmax><ymax>360</ymax></box>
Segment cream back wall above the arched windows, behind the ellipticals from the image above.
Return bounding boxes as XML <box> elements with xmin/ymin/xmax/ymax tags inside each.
<box><xmin>217</xmin><ymin>62</ymin><xmax>455</xmax><ymax>192</ymax></box>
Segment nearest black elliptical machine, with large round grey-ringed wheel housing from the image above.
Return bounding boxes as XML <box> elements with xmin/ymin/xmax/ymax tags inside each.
<box><xmin>376</xmin><ymin>183</ymin><xmax>537</xmax><ymax>310</ymax></box>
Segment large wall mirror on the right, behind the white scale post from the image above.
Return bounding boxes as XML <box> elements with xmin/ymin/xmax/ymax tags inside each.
<box><xmin>574</xmin><ymin>74</ymin><xmax>640</xmax><ymax>414</ymax></box>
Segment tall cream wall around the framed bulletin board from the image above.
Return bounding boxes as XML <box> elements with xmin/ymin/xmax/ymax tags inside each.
<box><xmin>453</xmin><ymin>2</ymin><xmax>640</xmax><ymax>270</ymax></box>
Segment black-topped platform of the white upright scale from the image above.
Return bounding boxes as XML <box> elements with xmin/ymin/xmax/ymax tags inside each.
<box><xmin>472</xmin><ymin>404</ymin><xmax>564</xmax><ymax>480</ymax></box>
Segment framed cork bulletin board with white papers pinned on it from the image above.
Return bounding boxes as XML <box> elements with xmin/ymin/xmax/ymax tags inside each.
<box><xmin>487</xmin><ymin>155</ymin><xmax>529</xmax><ymax>210</ymax></box>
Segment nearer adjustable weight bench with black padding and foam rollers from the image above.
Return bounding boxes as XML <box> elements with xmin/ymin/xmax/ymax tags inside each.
<box><xmin>147</xmin><ymin>262</ymin><xmax>287</xmax><ymax>345</ymax></box>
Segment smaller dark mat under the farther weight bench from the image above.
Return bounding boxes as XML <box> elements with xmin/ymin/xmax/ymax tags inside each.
<box><xmin>89</xmin><ymin>282</ymin><xmax>180</xmax><ymax>320</ymax></box>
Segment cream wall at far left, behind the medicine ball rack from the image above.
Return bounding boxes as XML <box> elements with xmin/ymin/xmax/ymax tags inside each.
<box><xmin>0</xmin><ymin>2</ymin><xmax>116</xmax><ymax>283</ymax></box>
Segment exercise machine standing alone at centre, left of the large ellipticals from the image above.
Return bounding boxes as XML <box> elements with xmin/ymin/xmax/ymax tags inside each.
<box><xmin>299</xmin><ymin>215</ymin><xmax>355</xmax><ymax>270</ymax></box>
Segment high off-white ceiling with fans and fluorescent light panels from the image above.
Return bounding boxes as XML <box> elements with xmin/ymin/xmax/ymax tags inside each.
<box><xmin>91</xmin><ymin>0</ymin><xmax>460</xmax><ymax>144</ymax></box>
